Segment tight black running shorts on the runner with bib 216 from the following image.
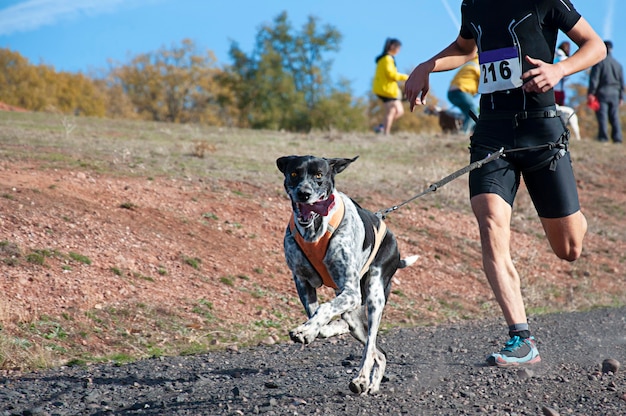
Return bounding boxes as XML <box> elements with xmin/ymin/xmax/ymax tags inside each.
<box><xmin>469</xmin><ymin>112</ymin><xmax>580</xmax><ymax>218</ymax></box>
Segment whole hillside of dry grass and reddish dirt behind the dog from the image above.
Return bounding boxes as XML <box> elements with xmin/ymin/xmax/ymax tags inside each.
<box><xmin>0</xmin><ymin>112</ymin><xmax>626</xmax><ymax>371</ymax></box>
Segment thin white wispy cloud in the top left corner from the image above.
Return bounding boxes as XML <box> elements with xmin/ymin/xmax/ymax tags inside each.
<box><xmin>0</xmin><ymin>0</ymin><xmax>129</xmax><ymax>36</ymax></box>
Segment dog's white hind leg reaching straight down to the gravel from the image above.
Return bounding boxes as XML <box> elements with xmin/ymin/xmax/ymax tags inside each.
<box><xmin>350</xmin><ymin>267</ymin><xmax>387</xmax><ymax>394</ymax></box>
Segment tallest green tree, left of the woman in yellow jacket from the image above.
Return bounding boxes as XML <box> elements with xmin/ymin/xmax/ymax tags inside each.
<box><xmin>220</xmin><ymin>12</ymin><xmax>365</xmax><ymax>131</ymax></box>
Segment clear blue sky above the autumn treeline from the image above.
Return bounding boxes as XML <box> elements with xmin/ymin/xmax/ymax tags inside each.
<box><xmin>0</xmin><ymin>0</ymin><xmax>626</xmax><ymax>108</ymax></box>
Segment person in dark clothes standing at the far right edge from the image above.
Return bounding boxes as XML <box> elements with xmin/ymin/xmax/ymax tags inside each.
<box><xmin>588</xmin><ymin>41</ymin><xmax>624</xmax><ymax>143</ymax></box>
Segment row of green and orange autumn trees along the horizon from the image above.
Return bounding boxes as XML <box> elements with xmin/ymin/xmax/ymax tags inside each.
<box><xmin>0</xmin><ymin>12</ymin><xmax>616</xmax><ymax>137</ymax></box>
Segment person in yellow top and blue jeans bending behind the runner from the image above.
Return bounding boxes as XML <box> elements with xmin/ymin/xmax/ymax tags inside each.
<box><xmin>448</xmin><ymin>55</ymin><xmax>480</xmax><ymax>134</ymax></box>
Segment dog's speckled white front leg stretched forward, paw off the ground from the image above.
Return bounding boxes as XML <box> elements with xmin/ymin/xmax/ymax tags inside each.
<box><xmin>289</xmin><ymin>279</ymin><xmax>361</xmax><ymax>344</ymax></box>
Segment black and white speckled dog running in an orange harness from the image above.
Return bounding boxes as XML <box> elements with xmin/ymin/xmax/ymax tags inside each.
<box><xmin>276</xmin><ymin>156</ymin><xmax>417</xmax><ymax>394</ymax></box>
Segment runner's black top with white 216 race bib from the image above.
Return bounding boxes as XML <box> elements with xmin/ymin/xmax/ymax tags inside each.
<box><xmin>460</xmin><ymin>0</ymin><xmax>581</xmax><ymax>112</ymax></box>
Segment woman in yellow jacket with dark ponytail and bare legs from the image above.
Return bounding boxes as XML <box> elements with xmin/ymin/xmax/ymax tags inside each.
<box><xmin>372</xmin><ymin>38</ymin><xmax>409</xmax><ymax>134</ymax></box>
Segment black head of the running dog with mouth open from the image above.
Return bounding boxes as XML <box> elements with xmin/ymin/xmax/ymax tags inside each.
<box><xmin>276</xmin><ymin>156</ymin><xmax>358</xmax><ymax>227</ymax></box>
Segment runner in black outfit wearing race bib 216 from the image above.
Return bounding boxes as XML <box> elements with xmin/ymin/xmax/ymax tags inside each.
<box><xmin>405</xmin><ymin>0</ymin><xmax>606</xmax><ymax>367</ymax></box>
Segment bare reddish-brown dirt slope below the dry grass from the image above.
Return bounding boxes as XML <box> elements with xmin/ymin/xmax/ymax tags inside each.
<box><xmin>0</xmin><ymin>136</ymin><xmax>626</xmax><ymax>369</ymax></box>
